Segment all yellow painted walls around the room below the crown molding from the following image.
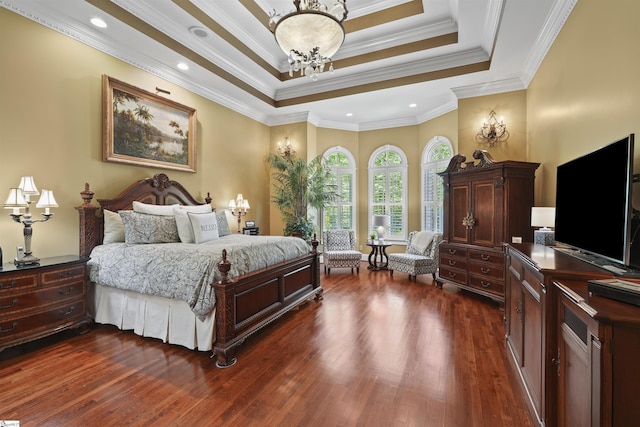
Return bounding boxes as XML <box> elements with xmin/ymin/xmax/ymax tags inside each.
<box><xmin>0</xmin><ymin>0</ymin><xmax>640</xmax><ymax>261</ymax></box>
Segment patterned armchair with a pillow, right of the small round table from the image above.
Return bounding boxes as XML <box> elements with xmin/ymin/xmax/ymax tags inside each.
<box><xmin>387</xmin><ymin>231</ymin><xmax>442</xmax><ymax>280</ymax></box>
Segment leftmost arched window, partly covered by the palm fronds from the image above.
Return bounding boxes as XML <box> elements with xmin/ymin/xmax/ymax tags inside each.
<box><xmin>322</xmin><ymin>147</ymin><xmax>356</xmax><ymax>234</ymax></box>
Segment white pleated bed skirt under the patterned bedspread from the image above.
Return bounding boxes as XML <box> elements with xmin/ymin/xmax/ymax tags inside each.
<box><xmin>87</xmin><ymin>282</ymin><xmax>215</xmax><ymax>351</ymax></box>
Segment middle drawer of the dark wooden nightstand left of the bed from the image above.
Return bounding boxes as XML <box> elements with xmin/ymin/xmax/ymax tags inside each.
<box><xmin>0</xmin><ymin>280</ymin><xmax>85</xmax><ymax>319</ymax></box>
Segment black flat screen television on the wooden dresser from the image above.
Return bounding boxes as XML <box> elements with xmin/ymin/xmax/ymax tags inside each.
<box><xmin>555</xmin><ymin>134</ymin><xmax>640</xmax><ymax>268</ymax></box>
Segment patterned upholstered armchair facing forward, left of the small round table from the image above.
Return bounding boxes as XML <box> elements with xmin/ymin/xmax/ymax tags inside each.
<box><xmin>322</xmin><ymin>230</ymin><xmax>362</xmax><ymax>274</ymax></box>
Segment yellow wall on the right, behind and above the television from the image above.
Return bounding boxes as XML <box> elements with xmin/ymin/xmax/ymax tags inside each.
<box><xmin>527</xmin><ymin>0</ymin><xmax>640</xmax><ymax>207</ymax></box>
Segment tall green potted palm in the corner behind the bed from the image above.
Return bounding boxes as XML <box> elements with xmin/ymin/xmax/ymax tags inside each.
<box><xmin>267</xmin><ymin>153</ymin><xmax>338</xmax><ymax>241</ymax></box>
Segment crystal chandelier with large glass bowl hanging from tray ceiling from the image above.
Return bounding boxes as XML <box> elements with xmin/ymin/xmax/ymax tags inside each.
<box><xmin>269</xmin><ymin>0</ymin><xmax>347</xmax><ymax>81</ymax></box>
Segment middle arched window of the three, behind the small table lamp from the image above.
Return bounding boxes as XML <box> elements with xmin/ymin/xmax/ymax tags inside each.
<box><xmin>368</xmin><ymin>145</ymin><xmax>407</xmax><ymax>241</ymax></box>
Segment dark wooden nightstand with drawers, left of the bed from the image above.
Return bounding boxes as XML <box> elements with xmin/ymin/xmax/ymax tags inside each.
<box><xmin>0</xmin><ymin>255</ymin><xmax>91</xmax><ymax>351</ymax></box>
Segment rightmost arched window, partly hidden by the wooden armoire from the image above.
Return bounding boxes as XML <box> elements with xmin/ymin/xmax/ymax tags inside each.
<box><xmin>421</xmin><ymin>136</ymin><xmax>453</xmax><ymax>232</ymax></box>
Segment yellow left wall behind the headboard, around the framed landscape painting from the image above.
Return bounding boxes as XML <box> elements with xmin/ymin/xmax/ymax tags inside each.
<box><xmin>0</xmin><ymin>8</ymin><xmax>270</xmax><ymax>261</ymax></box>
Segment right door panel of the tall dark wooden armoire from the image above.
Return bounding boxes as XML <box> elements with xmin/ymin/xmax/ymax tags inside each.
<box><xmin>471</xmin><ymin>182</ymin><xmax>501</xmax><ymax>246</ymax></box>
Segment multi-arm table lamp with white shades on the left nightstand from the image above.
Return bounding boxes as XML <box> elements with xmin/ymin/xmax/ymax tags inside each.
<box><xmin>4</xmin><ymin>176</ymin><xmax>58</xmax><ymax>267</ymax></box>
